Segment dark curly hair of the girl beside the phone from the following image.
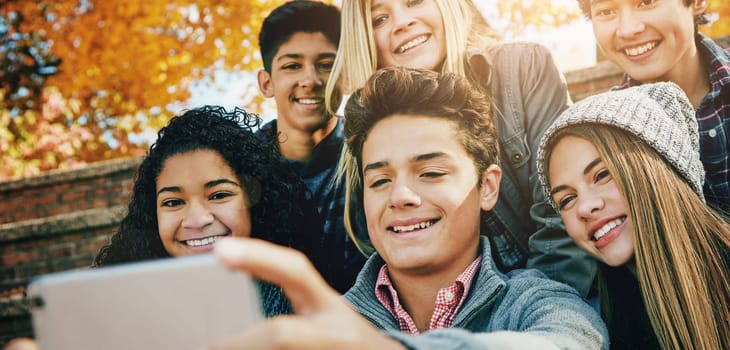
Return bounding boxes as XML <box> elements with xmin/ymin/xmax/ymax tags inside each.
<box><xmin>94</xmin><ymin>106</ymin><xmax>316</xmax><ymax>266</ymax></box>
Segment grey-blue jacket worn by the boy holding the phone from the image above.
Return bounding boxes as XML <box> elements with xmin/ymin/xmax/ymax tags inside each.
<box><xmin>345</xmin><ymin>236</ymin><xmax>609</xmax><ymax>350</ymax></box>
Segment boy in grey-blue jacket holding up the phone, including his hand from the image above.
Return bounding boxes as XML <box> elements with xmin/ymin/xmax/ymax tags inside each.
<box><xmin>216</xmin><ymin>67</ymin><xmax>609</xmax><ymax>350</ymax></box>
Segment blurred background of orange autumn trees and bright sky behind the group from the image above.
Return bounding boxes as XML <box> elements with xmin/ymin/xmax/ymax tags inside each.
<box><xmin>0</xmin><ymin>0</ymin><xmax>730</xmax><ymax>181</ymax></box>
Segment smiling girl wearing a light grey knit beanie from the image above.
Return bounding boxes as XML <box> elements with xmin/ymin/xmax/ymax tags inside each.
<box><xmin>537</xmin><ymin>83</ymin><xmax>730</xmax><ymax>349</ymax></box>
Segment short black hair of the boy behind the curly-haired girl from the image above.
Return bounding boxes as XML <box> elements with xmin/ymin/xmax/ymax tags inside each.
<box><xmin>259</xmin><ymin>0</ymin><xmax>340</xmax><ymax>73</ymax></box>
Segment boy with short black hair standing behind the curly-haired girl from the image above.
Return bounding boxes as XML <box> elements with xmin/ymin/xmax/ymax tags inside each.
<box><xmin>257</xmin><ymin>1</ymin><xmax>364</xmax><ymax>293</ymax></box>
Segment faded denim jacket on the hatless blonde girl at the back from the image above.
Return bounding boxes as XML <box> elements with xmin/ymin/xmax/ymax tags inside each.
<box><xmin>470</xmin><ymin>43</ymin><xmax>597</xmax><ymax>297</ymax></box>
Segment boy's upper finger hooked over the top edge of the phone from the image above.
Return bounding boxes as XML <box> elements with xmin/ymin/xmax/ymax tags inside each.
<box><xmin>215</xmin><ymin>238</ymin><xmax>339</xmax><ymax>314</ymax></box>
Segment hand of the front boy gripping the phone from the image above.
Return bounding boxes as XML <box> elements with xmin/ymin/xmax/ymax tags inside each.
<box><xmin>212</xmin><ymin>238</ymin><xmax>405</xmax><ymax>350</ymax></box>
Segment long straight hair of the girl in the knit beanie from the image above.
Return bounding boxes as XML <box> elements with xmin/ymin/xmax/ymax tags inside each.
<box><xmin>546</xmin><ymin>125</ymin><xmax>730</xmax><ymax>349</ymax></box>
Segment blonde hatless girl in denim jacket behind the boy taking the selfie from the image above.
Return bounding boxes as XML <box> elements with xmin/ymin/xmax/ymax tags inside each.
<box><xmin>326</xmin><ymin>0</ymin><xmax>597</xmax><ymax>297</ymax></box>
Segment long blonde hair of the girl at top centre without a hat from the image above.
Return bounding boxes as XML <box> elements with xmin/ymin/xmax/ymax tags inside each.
<box><xmin>325</xmin><ymin>0</ymin><xmax>494</xmax><ymax>255</ymax></box>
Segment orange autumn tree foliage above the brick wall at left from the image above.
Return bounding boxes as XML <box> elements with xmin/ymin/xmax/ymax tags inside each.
<box><xmin>0</xmin><ymin>0</ymin><xmax>288</xmax><ymax>178</ymax></box>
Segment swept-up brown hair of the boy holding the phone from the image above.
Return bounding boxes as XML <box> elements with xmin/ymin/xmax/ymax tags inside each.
<box><xmin>344</xmin><ymin>67</ymin><xmax>499</xmax><ymax>176</ymax></box>
